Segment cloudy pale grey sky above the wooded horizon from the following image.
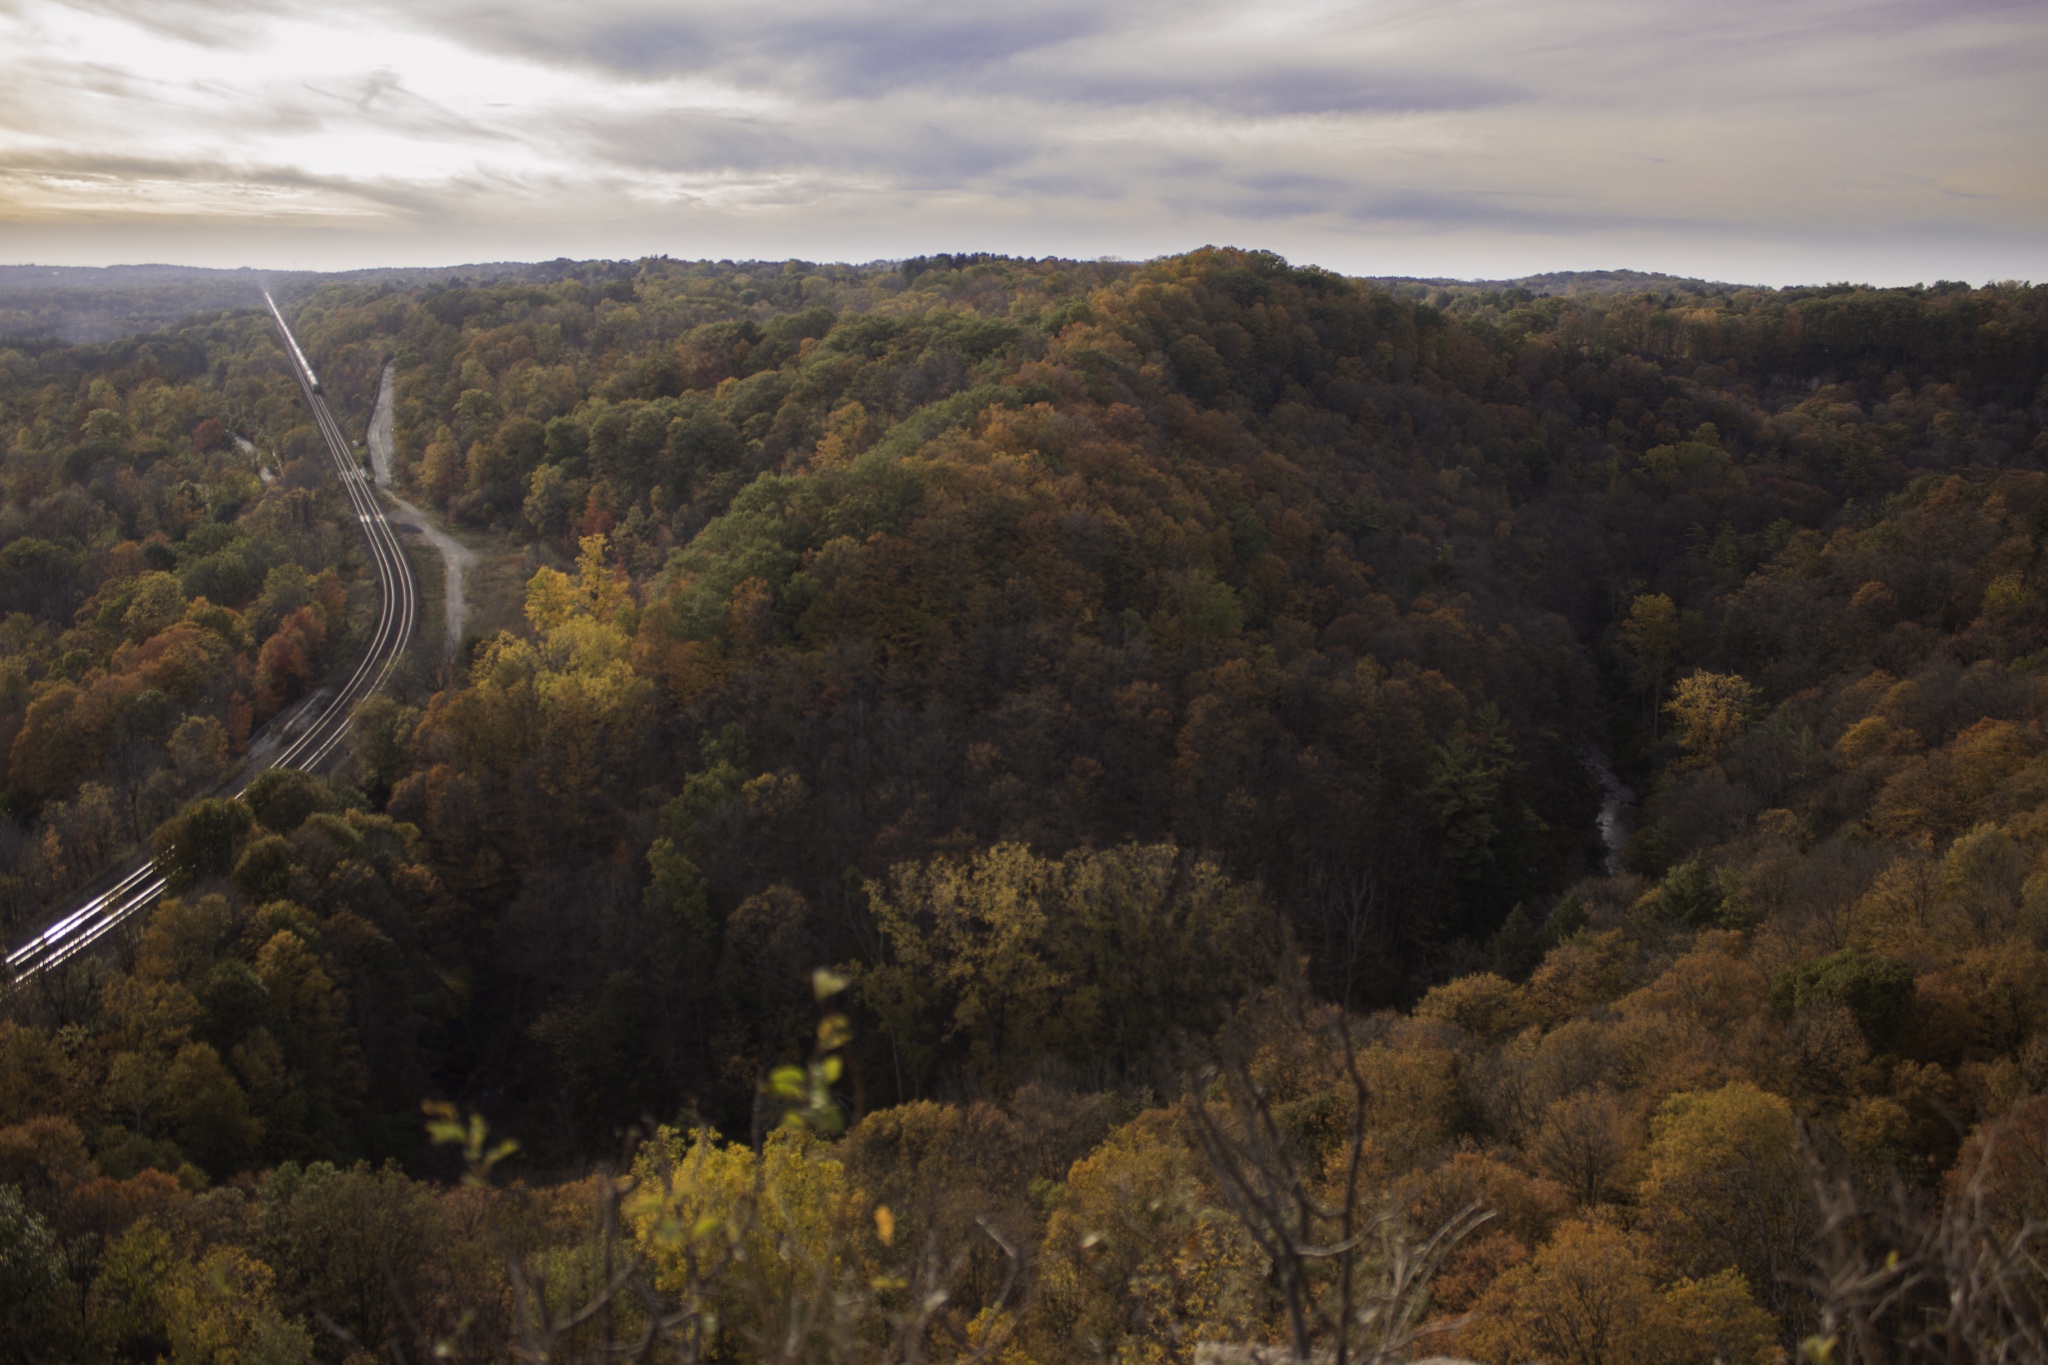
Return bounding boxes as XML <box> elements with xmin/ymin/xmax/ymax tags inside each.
<box><xmin>0</xmin><ymin>0</ymin><xmax>2048</xmax><ymax>284</ymax></box>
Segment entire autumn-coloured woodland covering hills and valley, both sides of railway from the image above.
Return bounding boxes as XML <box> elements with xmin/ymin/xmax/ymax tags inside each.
<box><xmin>0</xmin><ymin>250</ymin><xmax>2048</xmax><ymax>1365</ymax></box>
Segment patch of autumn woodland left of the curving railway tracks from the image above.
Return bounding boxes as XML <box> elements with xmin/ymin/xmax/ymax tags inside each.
<box><xmin>0</xmin><ymin>315</ymin><xmax>376</xmax><ymax>929</ymax></box>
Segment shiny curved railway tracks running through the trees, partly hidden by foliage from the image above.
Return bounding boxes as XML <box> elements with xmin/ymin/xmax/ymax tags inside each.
<box><xmin>6</xmin><ymin>293</ymin><xmax>420</xmax><ymax>982</ymax></box>
